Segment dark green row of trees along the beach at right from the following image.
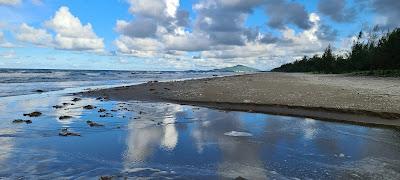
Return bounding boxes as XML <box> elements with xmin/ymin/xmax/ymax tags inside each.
<box><xmin>272</xmin><ymin>27</ymin><xmax>400</xmax><ymax>77</ymax></box>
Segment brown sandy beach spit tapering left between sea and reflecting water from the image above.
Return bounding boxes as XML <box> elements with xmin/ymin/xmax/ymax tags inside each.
<box><xmin>83</xmin><ymin>73</ymin><xmax>400</xmax><ymax>127</ymax></box>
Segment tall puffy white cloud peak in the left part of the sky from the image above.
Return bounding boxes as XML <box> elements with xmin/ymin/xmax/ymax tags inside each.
<box><xmin>45</xmin><ymin>6</ymin><xmax>104</xmax><ymax>51</ymax></box>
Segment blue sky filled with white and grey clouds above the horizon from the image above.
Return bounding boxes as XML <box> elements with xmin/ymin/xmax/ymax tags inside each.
<box><xmin>0</xmin><ymin>0</ymin><xmax>400</xmax><ymax>71</ymax></box>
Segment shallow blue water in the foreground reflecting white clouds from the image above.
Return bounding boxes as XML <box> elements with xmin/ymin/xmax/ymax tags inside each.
<box><xmin>0</xmin><ymin>93</ymin><xmax>400</xmax><ymax>179</ymax></box>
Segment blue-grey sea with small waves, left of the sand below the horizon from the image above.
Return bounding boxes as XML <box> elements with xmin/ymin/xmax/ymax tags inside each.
<box><xmin>0</xmin><ymin>69</ymin><xmax>234</xmax><ymax>97</ymax></box>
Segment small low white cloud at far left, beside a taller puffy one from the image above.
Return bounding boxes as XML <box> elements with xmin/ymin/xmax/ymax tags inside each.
<box><xmin>15</xmin><ymin>23</ymin><xmax>53</xmax><ymax>46</ymax></box>
